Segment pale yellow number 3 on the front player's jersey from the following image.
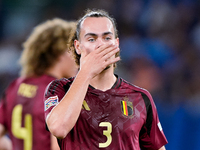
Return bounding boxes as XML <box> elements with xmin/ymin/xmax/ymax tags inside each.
<box><xmin>99</xmin><ymin>122</ymin><xmax>112</xmax><ymax>148</ymax></box>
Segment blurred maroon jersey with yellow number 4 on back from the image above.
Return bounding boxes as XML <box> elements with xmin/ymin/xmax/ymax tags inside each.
<box><xmin>0</xmin><ymin>75</ymin><xmax>55</xmax><ymax>150</ymax></box>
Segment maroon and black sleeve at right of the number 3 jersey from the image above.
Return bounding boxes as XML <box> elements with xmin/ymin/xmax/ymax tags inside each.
<box><xmin>140</xmin><ymin>92</ymin><xmax>168</xmax><ymax>150</ymax></box>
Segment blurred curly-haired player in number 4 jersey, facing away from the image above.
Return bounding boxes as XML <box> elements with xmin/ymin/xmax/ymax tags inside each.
<box><xmin>0</xmin><ymin>18</ymin><xmax>78</xmax><ymax>150</ymax></box>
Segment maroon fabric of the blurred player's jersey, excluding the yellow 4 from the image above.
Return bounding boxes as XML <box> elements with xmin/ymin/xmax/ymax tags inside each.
<box><xmin>0</xmin><ymin>75</ymin><xmax>55</xmax><ymax>150</ymax></box>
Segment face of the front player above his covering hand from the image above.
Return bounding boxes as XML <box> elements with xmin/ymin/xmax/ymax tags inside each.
<box><xmin>75</xmin><ymin>17</ymin><xmax>119</xmax><ymax>54</ymax></box>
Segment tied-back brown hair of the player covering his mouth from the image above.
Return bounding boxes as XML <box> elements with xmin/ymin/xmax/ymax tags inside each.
<box><xmin>69</xmin><ymin>9</ymin><xmax>120</xmax><ymax>67</ymax></box>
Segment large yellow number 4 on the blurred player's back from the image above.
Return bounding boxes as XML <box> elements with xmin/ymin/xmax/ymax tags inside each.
<box><xmin>12</xmin><ymin>104</ymin><xmax>32</xmax><ymax>150</ymax></box>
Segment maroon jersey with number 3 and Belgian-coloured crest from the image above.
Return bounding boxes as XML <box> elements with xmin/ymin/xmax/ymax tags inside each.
<box><xmin>44</xmin><ymin>77</ymin><xmax>167</xmax><ymax>150</ymax></box>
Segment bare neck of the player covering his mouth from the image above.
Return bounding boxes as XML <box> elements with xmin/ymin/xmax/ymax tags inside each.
<box><xmin>90</xmin><ymin>68</ymin><xmax>117</xmax><ymax>91</ymax></box>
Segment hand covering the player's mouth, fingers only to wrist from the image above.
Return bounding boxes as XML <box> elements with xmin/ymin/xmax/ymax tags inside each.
<box><xmin>80</xmin><ymin>44</ymin><xmax>120</xmax><ymax>78</ymax></box>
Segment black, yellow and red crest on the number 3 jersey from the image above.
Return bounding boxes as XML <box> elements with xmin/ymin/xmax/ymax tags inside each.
<box><xmin>121</xmin><ymin>96</ymin><xmax>133</xmax><ymax>116</ymax></box>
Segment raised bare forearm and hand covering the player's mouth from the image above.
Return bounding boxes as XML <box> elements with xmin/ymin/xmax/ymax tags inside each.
<box><xmin>46</xmin><ymin>45</ymin><xmax>119</xmax><ymax>138</ymax></box>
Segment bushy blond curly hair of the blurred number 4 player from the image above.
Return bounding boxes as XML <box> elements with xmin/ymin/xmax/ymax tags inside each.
<box><xmin>20</xmin><ymin>18</ymin><xmax>76</xmax><ymax>76</ymax></box>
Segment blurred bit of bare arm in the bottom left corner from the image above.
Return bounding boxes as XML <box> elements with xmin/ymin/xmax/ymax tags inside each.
<box><xmin>0</xmin><ymin>124</ymin><xmax>12</xmax><ymax>150</ymax></box>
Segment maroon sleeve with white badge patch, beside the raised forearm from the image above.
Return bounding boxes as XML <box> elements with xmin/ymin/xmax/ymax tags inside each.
<box><xmin>44</xmin><ymin>79</ymin><xmax>70</xmax><ymax>118</ymax></box>
